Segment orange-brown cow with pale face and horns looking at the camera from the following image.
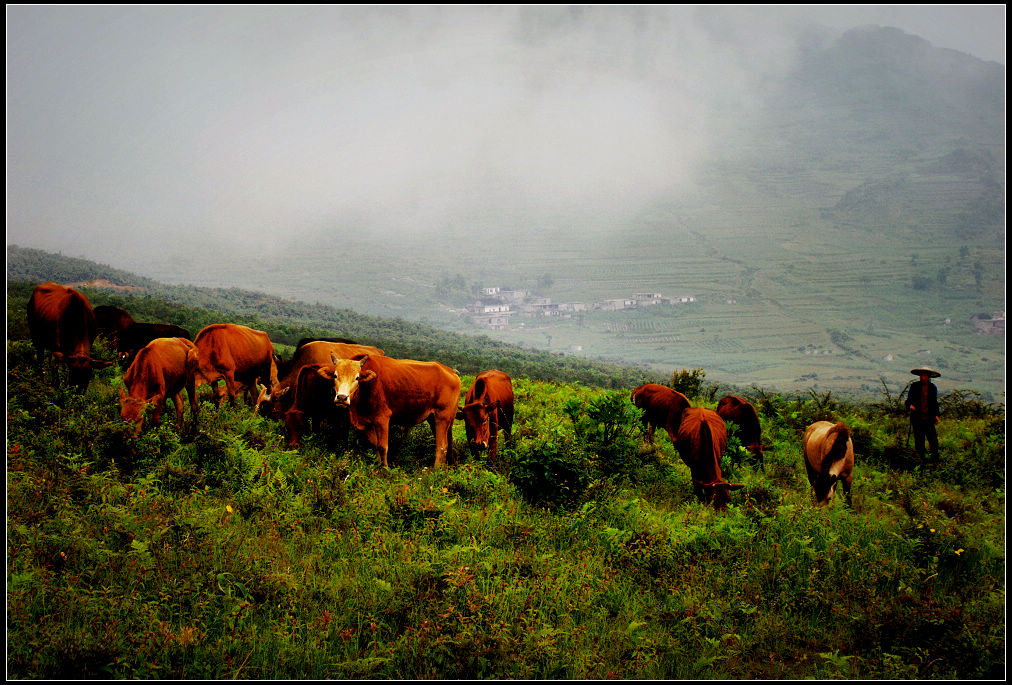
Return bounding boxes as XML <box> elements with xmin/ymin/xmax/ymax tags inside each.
<box><xmin>322</xmin><ymin>355</ymin><xmax>460</xmax><ymax>467</ymax></box>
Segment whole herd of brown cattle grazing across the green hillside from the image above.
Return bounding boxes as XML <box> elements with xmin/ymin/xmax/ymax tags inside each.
<box><xmin>27</xmin><ymin>281</ymin><xmax>854</xmax><ymax>508</ymax></box>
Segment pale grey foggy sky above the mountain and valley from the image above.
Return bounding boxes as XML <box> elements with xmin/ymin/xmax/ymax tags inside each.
<box><xmin>6</xmin><ymin>5</ymin><xmax>1005</xmax><ymax>268</ymax></box>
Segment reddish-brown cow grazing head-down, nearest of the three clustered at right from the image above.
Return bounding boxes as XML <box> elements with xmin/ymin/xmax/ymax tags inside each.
<box><xmin>675</xmin><ymin>407</ymin><xmax>745</xmax><ymax>509</ymax></box>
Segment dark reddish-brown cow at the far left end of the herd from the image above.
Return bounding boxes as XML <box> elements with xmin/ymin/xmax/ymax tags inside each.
<box><xmin>27</xmin><ymin>280</ymin><xmax>112</xmax><ymax>391</ymax></box>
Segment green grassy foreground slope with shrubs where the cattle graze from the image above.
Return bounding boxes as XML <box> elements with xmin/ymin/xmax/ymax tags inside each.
<box><xmin>7</xmin><ymin>285</ymin><xmax>1005</xmax><ymax>679</ymax></box>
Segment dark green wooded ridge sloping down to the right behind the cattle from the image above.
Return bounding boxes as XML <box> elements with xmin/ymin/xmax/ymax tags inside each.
<box><xmin>7</xmin><ymin>246</ymin><xmax>657</xmax><ymax>388</ymax></box>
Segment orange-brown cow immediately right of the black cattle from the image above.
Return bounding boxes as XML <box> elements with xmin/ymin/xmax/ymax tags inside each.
<box><xmin>193</xmin><ymin>324</ymin><xmax>277</xmax><ymax>405</ymax></box>
